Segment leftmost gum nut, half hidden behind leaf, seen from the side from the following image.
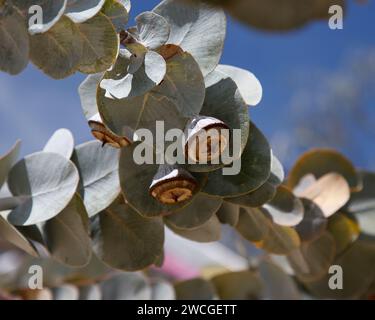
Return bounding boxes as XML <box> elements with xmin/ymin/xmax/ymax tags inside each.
<box><xmin>88</xmin><ymin>113</ymin><xmax>131</xmax><ymax>149</ymax></box>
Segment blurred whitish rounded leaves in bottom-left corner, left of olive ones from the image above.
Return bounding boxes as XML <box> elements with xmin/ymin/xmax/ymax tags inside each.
<box><xmin>0</xmin><ymin>252</ymin><xmax>176</xmax><ymax>300</ymax></box>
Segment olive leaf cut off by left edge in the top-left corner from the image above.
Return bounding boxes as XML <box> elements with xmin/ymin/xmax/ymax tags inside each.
<box><xmin>0</xmin><ymin>6</ymin><xmax>29</xmax><ymax>75</ymax></box>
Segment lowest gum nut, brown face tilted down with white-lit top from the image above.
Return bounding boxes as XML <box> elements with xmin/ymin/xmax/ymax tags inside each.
<box><xmin>150</xmin><ymin>165</ymin><xmax>198</xmax><ymax>205</ymax></box>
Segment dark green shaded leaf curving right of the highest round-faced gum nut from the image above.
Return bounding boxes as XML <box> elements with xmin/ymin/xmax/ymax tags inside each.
<box><xmin>203</xmin><ymin>123</ymin><xmax>271</xmax><ymax>197</ymax></box>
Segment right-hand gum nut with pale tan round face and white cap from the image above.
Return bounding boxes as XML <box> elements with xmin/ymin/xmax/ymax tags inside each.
<box><xmin>184</xmin><ymin>116</ymin><xmax>229</xmax><ymax>163</ymax></box>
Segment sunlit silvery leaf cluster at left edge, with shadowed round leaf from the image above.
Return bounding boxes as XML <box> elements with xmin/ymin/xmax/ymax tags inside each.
<box><xmin>0</xmin><ymin>130</ymin><xmax>120</xmax><ymax>266</ymax></box>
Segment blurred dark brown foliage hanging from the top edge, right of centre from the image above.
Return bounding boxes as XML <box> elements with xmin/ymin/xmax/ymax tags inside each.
<box><xmin>191</xmin><ymin>0</ymin><xmax>346</xmax><ymax>32</ymax></box>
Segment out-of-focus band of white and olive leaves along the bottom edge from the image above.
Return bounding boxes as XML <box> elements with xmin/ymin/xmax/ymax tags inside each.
<box><xmin>0</xmin><ymin>252</ymin><xmax>301</xmax><ymax>300</ymax></box>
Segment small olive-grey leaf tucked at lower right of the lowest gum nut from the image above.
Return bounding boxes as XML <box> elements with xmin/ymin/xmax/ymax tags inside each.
<box><xmin>164</xmin><ymin>193</ymin><xmax>223</xmax><ymax>230</ymax></box>
